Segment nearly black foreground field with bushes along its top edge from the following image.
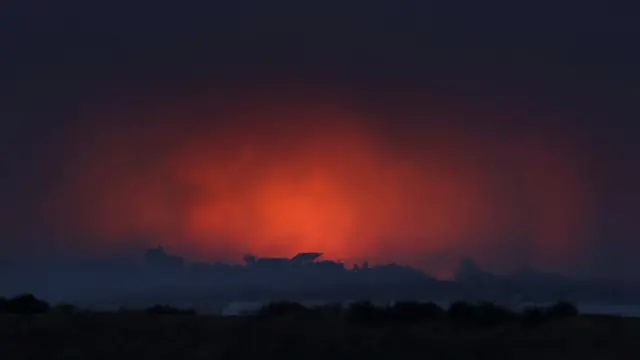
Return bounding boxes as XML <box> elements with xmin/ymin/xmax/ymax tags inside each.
<box><xmin>0</xmin><ymin>300</ymin><xmax>640</xmax><ymax>360</ymax></box>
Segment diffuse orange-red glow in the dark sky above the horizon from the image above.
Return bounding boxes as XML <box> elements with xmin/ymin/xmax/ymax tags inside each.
<box><xmin>46</xmin><ymin>93</ymin><xmax>590</xmax><ymax>271</ymax></box>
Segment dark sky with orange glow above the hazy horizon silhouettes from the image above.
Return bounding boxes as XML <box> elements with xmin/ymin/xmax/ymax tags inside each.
<box><xmin>0</xmin><ymin>0</ymin><xmax>640</xmax><ymax>277</ymax></box>
